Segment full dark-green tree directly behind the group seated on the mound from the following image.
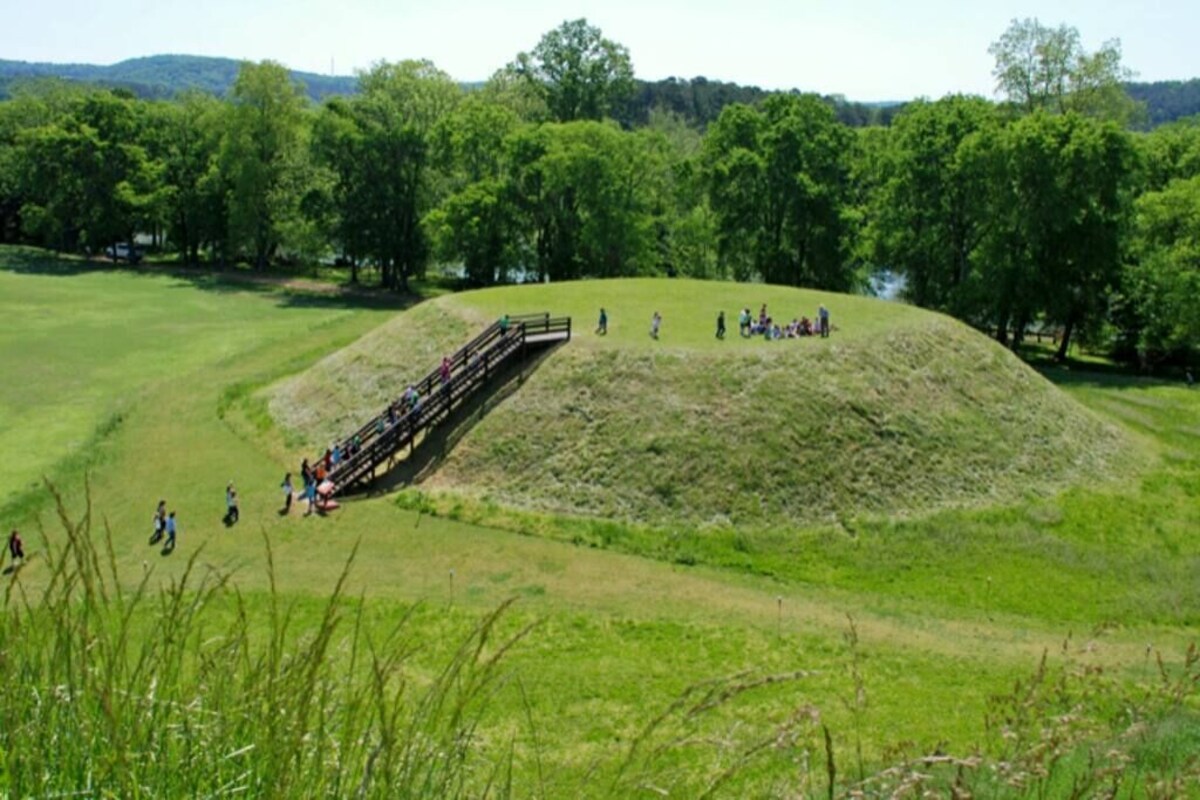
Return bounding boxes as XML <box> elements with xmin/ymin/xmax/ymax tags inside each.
<box><xmin>704</xmin><ymin>95</ymin><xmax>854</xmax><ymax>290</ymax></box>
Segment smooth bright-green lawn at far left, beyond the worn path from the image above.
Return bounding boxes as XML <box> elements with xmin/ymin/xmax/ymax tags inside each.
<box><xmin>0</xmin><ymin>249</ymin><xmax>386</xmax><ymax>513</ymax></box>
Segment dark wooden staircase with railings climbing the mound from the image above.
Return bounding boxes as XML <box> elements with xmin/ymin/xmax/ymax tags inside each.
<box><xmin>313</xmin><ymin>313</ymin><xmax>571</xmax><ymax>497</ymax></box>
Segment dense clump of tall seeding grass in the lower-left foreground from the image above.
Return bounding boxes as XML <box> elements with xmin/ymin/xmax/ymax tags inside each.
<box><xmin>0</xmin><ymin>482</ymin><xmax>528</xmax><ymax>798</ymax></box>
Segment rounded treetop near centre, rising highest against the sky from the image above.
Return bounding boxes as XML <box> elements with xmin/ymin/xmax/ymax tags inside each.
<box><xmin>509</xmin><ymin>19</ymin><xmax>634</xmax><ymax>122</ymax></box>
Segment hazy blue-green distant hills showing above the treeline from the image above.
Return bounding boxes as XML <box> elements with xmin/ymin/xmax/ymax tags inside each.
<box><xmin>0</xmin><ymin>55</ymin><xmax>1200</xmax><ymax>128</ymax></box>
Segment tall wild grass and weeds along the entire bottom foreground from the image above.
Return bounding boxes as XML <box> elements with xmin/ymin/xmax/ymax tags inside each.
<box><xmin>0</xmin><ymin>482</ymin><xmax>1200</xmax><ymax>798</ymax></box>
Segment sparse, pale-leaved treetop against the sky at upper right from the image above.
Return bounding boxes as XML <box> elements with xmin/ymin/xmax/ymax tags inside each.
<box><xmin>988</xmin><ymin>18</ymin><xmax>1139</xmax><ymax>124</ymax></box>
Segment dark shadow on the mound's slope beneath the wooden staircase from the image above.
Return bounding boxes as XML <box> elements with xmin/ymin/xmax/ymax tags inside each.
<box><xmin>348</xmin><ymin>342</ymin><xmax>565</xmax><ymax>498</ymax></box>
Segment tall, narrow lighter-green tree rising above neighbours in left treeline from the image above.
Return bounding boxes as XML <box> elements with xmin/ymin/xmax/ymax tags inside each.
<box><xmin>221</xmin><ymin>61</ymin><xmax>306</xmax><ymax>270</ymax></box>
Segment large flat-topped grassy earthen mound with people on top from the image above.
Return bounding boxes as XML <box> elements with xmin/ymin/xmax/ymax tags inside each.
<box><xmin>271</xmin><ymin>281</ymin><xmax>1129</xmax><ymax>527</ymax></box>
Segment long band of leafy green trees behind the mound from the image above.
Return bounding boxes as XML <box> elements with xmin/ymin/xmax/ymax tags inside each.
<box><xmin>0</xmin><ymin>20</ymin><xmax>1200</xmax><ymax>363</ymax></box>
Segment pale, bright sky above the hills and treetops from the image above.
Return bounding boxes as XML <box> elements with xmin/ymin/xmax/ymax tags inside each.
<box><xmin>9</xmin><ymin>0</ymin><xmax>1200</xmax><ymax>102</ymax></box>
